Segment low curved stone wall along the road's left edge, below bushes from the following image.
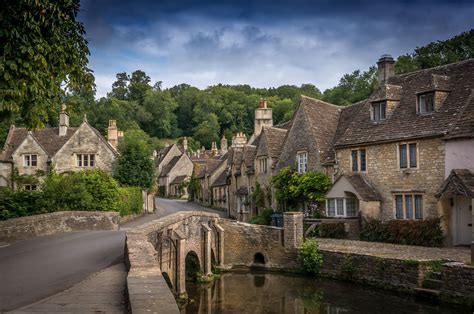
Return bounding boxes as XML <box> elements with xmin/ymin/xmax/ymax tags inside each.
<box><xmin>0</xmin><ymin>211</ymin><xmax>120</xmax><ymax>242</ymax></box>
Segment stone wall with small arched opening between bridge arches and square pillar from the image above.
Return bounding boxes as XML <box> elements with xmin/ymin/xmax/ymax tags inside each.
<box><xmin>219</xmin><ymin>219</ymin><xmax>297</xmax><ymax>270</ymax></box>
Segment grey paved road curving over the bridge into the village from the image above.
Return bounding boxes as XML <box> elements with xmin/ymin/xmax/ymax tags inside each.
<box><xmin>0</xmin><ymin>198</ymin><xmax>225</xmax><ymax>312</ymax></box>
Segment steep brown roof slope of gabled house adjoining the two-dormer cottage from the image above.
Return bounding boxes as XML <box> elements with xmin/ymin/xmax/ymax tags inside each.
<box><xmin>300</xmin><ymin>96</ymin><xmax>343</xmax><ymax>163</ymax></box>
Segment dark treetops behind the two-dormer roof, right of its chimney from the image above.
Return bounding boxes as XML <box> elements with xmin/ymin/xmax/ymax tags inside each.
<box><xmin>395</xmin><ymin>29</ymin><xmax>474</xmax><ymax>74</ymax></box>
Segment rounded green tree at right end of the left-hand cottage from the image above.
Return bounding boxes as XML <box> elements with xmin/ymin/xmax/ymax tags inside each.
<box><xmin>114</xmin><ymin>130</ymin><xmax>154</xmax><ymax>189</ymax></box>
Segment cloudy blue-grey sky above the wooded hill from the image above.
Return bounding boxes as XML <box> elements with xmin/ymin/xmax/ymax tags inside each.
<box><xmin>79</xmin><ymin>0</ymin><xmax>474</xmax><ymax>98</ymax></box>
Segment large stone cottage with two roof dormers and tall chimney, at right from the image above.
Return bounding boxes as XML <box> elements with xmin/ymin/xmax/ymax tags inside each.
<box><xmin>326</xmin><ymin>55</ymin><xmax>474</xmax><ymax>245</ymax></box>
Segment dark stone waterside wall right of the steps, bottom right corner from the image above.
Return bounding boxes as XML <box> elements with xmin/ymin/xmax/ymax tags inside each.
<box><xmin>441</xmin><ymin>263</ymin><xmax>474</xmax><ymax>306</ymax></box>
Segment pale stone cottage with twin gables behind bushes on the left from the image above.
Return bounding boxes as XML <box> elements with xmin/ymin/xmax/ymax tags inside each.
<box><xmin>0</xmin><ymin>106</ymin><xmax>123</xmax><ymax>190</ymax></box>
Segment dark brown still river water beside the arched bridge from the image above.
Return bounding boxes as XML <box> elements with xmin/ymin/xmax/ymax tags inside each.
<box><xmin>181</xmin><ymin>273</ymin><xmax>472</xmax><ymax>314</ymax></box>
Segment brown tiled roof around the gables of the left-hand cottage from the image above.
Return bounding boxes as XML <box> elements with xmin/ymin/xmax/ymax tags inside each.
<box><xmin>1</xmin><ymin>127</ymin><xmax>78</xmax><ymax>160</ymax></box>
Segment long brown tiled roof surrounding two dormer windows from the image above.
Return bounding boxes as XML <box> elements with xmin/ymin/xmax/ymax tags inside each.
<box><xmin>335</xmin><ymin>59</ymin><xmax>474</xmax><ymax>147</ymax></box>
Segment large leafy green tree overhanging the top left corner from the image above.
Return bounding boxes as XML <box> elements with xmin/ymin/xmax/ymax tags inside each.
<box><xmin>0</xmin><ymin>0</ymin><xmax>94</xmax><ymax>128</ymax></box>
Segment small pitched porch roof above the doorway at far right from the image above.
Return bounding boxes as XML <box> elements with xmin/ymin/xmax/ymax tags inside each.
<box><xmin>436</xmin><ymin>169</ymin><xmax>474</xmax><ymax>198</ymax></box>
